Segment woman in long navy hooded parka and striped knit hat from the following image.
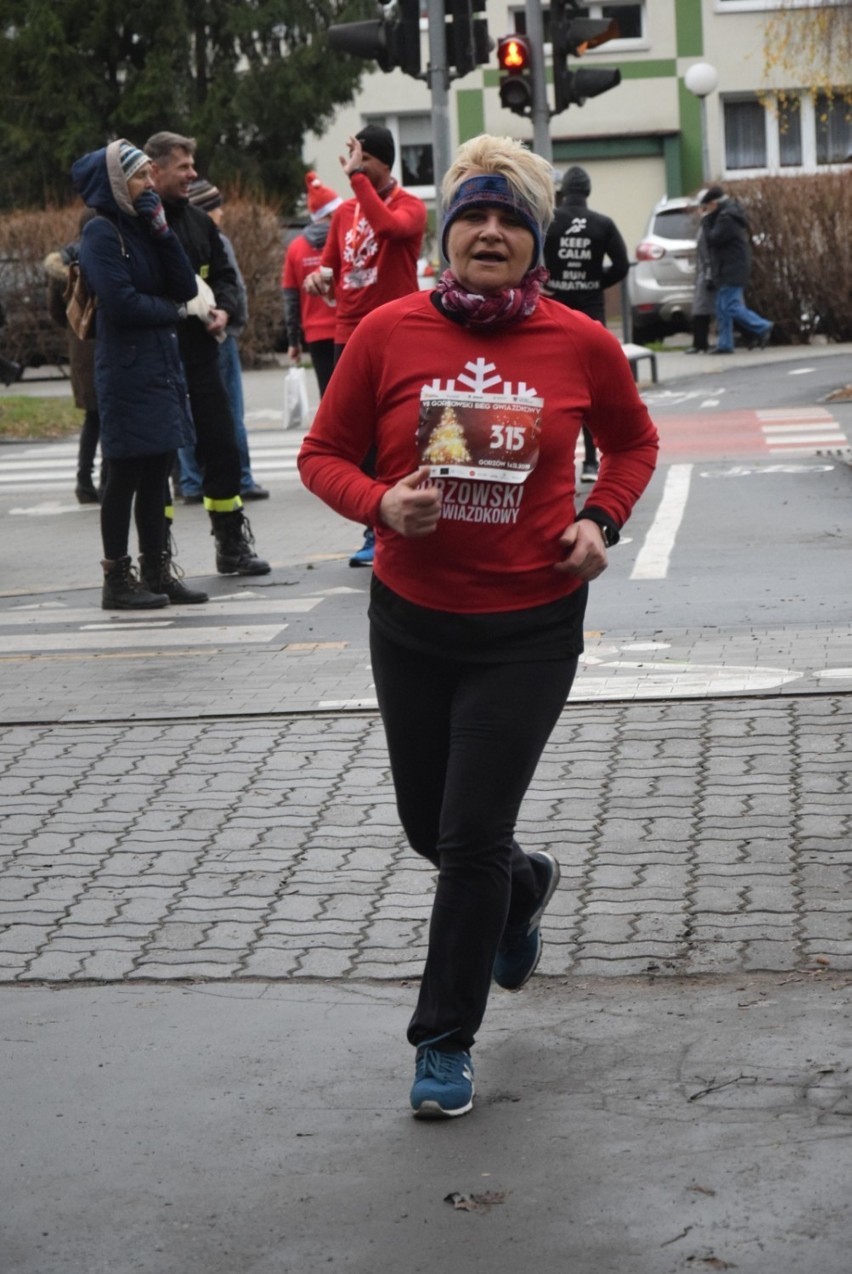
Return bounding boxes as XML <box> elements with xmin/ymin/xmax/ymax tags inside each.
<box><xmin>71</xmin><ymin>139</ymin><xmax>202</xmax><ymax>610</ymax></box>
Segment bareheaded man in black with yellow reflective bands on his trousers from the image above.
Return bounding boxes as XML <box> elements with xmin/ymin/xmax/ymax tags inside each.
<box><xmin>145</xmin><ymin>132</ymin><xmax>270</xmax><ymax>575</ymax></box>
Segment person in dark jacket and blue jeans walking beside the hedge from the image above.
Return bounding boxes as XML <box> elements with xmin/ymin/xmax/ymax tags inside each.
<box><xmin>700</xmin><ymin>186</ymin><xmax>774</xmax><ymax>354</ymax></box>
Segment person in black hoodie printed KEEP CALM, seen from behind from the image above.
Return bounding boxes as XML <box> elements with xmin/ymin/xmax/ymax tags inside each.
<box><xmin>544</xmin><ymin>166</ymin><xmax>630</xmax><ymax>482</ymax></box>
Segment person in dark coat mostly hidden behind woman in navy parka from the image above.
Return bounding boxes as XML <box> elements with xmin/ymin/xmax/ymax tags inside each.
<box><xmin>45</xmin><ymin>208</ymin><xmax>107</xmax><ymax>505</ymax></box>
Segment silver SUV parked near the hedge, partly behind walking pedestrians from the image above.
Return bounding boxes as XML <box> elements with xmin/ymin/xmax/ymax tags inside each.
<box><xmin>627</xmin><ymin>199</ymin><xmax>698</xmax><ymax>344</ymax></box>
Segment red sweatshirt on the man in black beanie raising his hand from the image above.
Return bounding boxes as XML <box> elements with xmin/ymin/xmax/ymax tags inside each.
<box><xmin>322</xmin><ymin>172</ymin><xmax>427</xmax><ymax>345</ymax></box>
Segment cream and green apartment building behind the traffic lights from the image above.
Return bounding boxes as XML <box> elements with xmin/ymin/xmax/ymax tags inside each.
<box><xmin>303</xmin><ymin>0</ymin><xmax>852</xmax><ymax>261</ymax></box>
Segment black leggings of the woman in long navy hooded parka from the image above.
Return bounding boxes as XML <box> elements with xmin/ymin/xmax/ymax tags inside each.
<box><xmin>101</xmin><ymin>451</ymin><xmax>174</xmax><ymax>562</ymax></box>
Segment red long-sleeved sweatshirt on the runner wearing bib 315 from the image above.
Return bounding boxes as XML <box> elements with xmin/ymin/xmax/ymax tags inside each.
<box><xmin>299</xmin><ymin>293</ymin><xmax>658</xmax><ymax>614</ymax></box>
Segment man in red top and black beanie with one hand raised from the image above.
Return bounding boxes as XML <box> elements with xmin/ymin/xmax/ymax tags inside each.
<box><xmin>304</xmin><ymin>124</ymin><xmax>427</xmax><ymax>566</ymax></box>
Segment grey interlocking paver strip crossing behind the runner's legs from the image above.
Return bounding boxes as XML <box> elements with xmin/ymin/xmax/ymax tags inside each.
<box><xmin>0</xmin><ymin>694</ymin><xmax>852</xmax><ymax>982</ymax></box>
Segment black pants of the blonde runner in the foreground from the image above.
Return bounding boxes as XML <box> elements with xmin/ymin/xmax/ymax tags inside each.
<box><xmin>371</xmin><ymin>626</ymin><xmax>577</xmax><ymax>1049</ymax></box>
